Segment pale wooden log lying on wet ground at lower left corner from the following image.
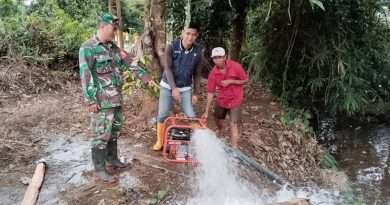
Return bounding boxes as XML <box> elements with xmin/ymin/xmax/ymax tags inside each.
<box><xmin>21</xmin><ymin>162</ymin><xmax>46</xmax><ymax>205</ymax></box>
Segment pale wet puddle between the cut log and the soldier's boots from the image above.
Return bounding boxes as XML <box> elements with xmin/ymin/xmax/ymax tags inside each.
<box><xmin>37</xmin><ymin>135</ymin><xmax>92</xmax><ymax>204</ymax></box>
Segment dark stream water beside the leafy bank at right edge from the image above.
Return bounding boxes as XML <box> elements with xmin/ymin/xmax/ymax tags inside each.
<box><xmin>332</xmin><ymin>124</ymin><xmax>390</xmax><ymax>205</ymax></box>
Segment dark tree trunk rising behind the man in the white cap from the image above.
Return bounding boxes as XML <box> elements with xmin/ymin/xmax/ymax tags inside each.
<box><xmin>229</xmin><ymin>0</ymin><xmax>249</xmax><ymax>60</ymax></box>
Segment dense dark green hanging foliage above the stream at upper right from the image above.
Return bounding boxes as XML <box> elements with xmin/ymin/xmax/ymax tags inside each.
<box><xmin>247</xmin><ymin>0</ymin><xmax>390</xmax><ymax>115</ymax></box>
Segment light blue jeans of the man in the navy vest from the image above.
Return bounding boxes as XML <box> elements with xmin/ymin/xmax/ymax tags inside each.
<box><xmin>157</xmin><ymin>87</ymin><xmax>196</xmax><ymax>123</ymax></box>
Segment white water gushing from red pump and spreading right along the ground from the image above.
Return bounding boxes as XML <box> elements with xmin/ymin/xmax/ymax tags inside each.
<box><xmin>187</xmin><ymin>130</ymin><xmax>341</xmax><ymax>205</ymax></box>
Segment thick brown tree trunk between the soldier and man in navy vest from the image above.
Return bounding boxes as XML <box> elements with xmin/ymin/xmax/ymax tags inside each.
<box><xmin>132</xmin><ymin>0</ymin><xmax>166</xmax><ymax>121</ymax></box>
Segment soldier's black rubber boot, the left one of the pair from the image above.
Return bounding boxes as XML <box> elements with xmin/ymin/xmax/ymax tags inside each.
<box><xmin>91</xmin><ymin>148</ymin><xmax>116</xmax><ymax>183</ymax></box>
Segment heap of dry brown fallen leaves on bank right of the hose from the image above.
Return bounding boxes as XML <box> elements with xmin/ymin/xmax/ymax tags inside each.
<box><xmin>243</xmin><ymin>122</ymin><xmax>322</xmax><ymax>184</ymax></box>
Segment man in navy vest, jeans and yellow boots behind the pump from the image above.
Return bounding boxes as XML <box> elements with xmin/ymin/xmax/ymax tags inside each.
<box><xmin>153</xmin><ymin>23</ymin><xmax>202</xmax><ymax>151</ymax></box>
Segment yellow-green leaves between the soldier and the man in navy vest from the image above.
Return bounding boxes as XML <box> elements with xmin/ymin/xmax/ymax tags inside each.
<box><xmin>122</xmin><ymin>55</ymin><xmax>160</xmax><ymax>97</ymax></box>
